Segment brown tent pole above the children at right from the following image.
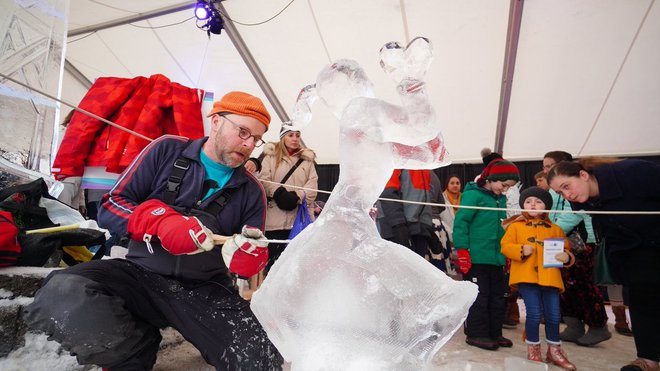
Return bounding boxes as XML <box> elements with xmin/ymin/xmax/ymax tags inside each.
<box><xmin>494</xmin><ymin>0</ymin><xmax>525</xmax><ymax>155</ymax></box>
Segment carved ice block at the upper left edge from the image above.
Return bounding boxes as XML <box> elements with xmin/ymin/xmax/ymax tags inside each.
<box><xmin>0</xmin><ymin>0</ymin><xmax>69</xmax><ymax>179</ymax></box>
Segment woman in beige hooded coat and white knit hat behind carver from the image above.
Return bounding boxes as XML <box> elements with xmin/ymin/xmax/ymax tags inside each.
<box><xmin>259</xmin><ymin>127</ymin><xmax>318</xmax><ymax>271</ymax></box>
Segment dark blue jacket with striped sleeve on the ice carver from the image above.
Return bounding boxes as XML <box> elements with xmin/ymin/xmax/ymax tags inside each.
<box><xmin>98</xmin><ymin>135</ymin><xmax>266</xmax><ymax>282</ymax></box>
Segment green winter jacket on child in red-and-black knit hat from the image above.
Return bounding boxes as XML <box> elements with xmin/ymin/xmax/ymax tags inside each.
<box><xmin>454</xmin><ymin>182</ymin><xmax>506</xmax><ymax>265</ymax></box>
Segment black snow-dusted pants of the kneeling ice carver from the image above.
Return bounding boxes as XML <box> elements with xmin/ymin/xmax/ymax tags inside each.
<box><xmin>24</xmin><ymin>259</ymin><xmax>282</xmax><ymax>370</ymax></box>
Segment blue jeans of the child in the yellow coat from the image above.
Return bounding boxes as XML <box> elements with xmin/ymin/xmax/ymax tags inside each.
<box><xmin>518</xmin><ymin>283</ymin><xmax>561</xmax><ymax>344</ymax></box>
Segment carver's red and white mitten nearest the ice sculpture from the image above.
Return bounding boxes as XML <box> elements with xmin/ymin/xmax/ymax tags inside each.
<box><xmin>222</xmin><ymin>225</ymin><xmax>268</xmax><ymax>278</ymax></box>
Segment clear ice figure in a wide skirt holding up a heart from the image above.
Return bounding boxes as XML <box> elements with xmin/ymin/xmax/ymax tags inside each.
<box><xmin>251</xmin><ymin>38</ymin><xmax>477</xmax><ymax>371</ymax></box>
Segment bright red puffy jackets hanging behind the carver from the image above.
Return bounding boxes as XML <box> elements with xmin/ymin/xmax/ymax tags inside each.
<box><xmin>52</xmin><ymin>74</ymin><xmax>204</xmax><ymax>179</ymax></box>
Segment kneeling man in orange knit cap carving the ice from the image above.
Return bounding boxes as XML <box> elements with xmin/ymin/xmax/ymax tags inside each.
<box><xmin>25</xmin><ymin>92</ymin><xmax>282</xmax><ymax>370</ymax></box>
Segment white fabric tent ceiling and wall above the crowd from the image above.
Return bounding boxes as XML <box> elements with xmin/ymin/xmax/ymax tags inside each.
<box><xmin>62</xmin><ymin>0</ymin><xmax>660</xmax><ymax>163</ymax></box>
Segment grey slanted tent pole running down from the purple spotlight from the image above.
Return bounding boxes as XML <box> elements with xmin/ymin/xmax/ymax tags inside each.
<box><xmin>215</xmin><ymin>2</ymin><xmax>289</xmax><ymax>122</ymax></box>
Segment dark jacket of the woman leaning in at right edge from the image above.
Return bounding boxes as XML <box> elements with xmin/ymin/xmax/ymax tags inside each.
<box><xmin>571</xmin><ymin>159</ymin><xmax>660</xmax><ymax>276</ymax></box>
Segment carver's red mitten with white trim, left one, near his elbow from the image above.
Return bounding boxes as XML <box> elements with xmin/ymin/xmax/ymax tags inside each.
<box><xmin>127</xmin><ymin>199</ymin><xmax>215</xmax><ymax>255</ymax></box>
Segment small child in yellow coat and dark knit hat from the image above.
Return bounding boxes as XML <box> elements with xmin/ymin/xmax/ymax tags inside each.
<box><xmin>501</xmin><ymin>187</ymin><xmax>576</xmax><ymax>370</ymax></box>
